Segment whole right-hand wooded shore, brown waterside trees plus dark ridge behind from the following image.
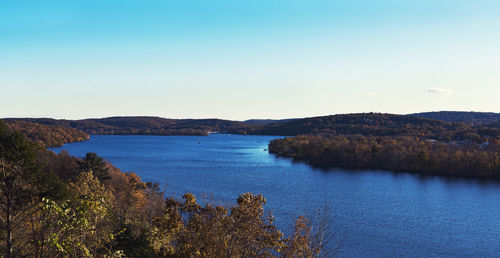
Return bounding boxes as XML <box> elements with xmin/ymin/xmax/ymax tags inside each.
<box><xmin>261</xmin><ymin>113</ymin><xmax>500</xmax><ymax>179</ymax></box>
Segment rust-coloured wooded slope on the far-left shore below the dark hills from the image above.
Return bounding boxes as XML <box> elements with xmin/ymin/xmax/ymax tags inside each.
<box><xmin>7</xmin><ymin>121</ymin><xmax>90</xmax><ymax>147</ymax></box>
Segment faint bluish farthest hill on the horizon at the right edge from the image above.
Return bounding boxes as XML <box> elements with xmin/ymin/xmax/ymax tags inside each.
<box><xmin>408</xmin><ymin>111</ymin><xmax>500</xmax><ymax>125</ymax></box>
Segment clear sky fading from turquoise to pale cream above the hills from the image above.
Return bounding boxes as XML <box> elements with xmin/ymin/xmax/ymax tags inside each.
<box><xmin>0</xmin><ymin>0</ymin><xmax>500</xmax><ymax>120</ymax></box>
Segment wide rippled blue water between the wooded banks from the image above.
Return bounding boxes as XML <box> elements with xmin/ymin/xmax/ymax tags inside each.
<box><xmin>49</xmin><ymin>134</ymin><xmax>500</xmax><ymax>257</ymax></box>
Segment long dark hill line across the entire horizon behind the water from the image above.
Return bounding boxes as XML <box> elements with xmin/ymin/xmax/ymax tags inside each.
<box><xmin>6</xmin><ymin>113</ymin><xmax>500</xmax><ymax>142</ymax></box>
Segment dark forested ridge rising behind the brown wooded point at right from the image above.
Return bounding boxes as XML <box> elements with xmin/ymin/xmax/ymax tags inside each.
<box><xmin>252</xmin><ymin>113</ymin><xmax>500</xmax><ymax>142</ymax></box>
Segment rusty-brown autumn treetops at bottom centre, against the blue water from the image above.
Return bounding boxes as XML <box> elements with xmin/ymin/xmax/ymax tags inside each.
<box><xmin>153</xmin><ymin>193</ymin><xmax>292</xmax><ymax>257</ymax></box>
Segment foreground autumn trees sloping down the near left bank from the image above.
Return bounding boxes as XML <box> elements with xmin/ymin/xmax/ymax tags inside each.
<box><xmin>0</xmin><ymin>120</ymin><xmax>331</xmax><ymax>257</ymax></box>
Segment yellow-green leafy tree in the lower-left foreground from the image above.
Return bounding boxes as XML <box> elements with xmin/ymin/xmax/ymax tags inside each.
<box><xmin>38</xmin><ymin>172</ymin><xmax>114</xmax><ymax>257</ymax></box>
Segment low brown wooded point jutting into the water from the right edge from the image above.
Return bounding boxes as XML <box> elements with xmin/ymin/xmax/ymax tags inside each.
<box><xmin>269</xmin><ymin>135</ymin><xmax>500</xmax><ymax>179</ymax></box>
